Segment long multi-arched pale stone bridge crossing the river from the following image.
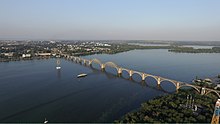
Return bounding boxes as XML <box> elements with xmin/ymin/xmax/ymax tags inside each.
<box><xmin>62</xmin><ymin>54</ymin><xmax>220</xmax><ymax>98</ymax></box>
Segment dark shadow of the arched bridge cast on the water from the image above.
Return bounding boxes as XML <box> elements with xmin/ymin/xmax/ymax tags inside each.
<box><xmin>88</xmin><ymin>64</ymin><xmax>175</xmax><ymax>94</ymax></box>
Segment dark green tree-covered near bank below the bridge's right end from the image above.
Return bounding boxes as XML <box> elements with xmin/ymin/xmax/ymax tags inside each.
<box><xmin>115</xmin><ymin>90</ymin><xmax>217</xmax><ymax>123</ymax></box>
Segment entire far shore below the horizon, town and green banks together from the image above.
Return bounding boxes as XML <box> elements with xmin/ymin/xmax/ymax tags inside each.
<box><xmin>0</xmin><ymin>40</ymin><xmax>220</xmax><ymax>62</ymax></box>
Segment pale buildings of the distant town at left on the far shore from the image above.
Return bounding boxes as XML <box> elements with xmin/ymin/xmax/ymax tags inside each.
<box><xmin>0</xmin><ymin>41</ymin><xmax>115</xmax><ymax>61</ymax></box>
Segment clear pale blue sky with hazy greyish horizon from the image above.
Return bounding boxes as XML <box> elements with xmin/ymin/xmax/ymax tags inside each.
<box><xmin>0</xmin><ymin>0</ymin><xmax>220</xmax><ymax>41</ymax></box>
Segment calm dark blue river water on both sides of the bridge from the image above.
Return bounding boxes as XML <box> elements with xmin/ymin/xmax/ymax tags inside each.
<box><xmin>0</xmin><ymin>50</ymin><xmax>220</xmax><ymax>122</ymax></box>
